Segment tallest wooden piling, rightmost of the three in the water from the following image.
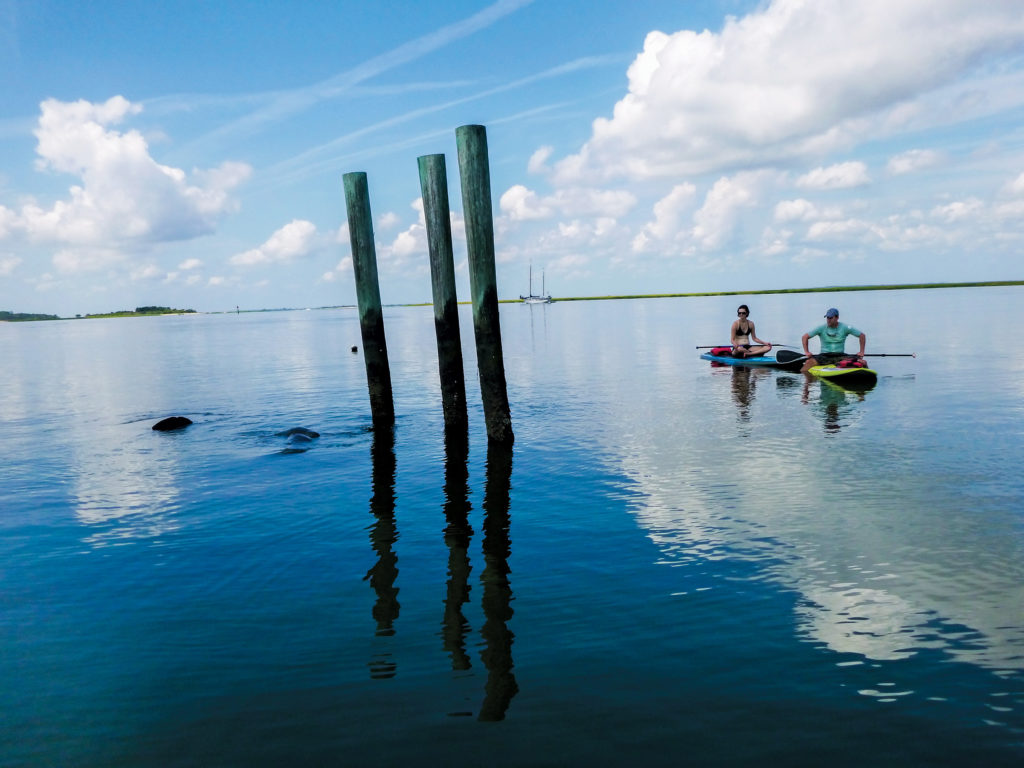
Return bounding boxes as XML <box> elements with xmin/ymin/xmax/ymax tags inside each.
<box><xmin>456</xmin><ymin>125</ymin><xmax>515</xmax><ymax>443</ymax></box>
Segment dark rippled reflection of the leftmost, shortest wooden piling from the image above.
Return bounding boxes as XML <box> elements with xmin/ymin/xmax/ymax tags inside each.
<box><xmin>364</xmin><ymin>426</ymin><xmax>400</xmax><ymax>678</ymax></box>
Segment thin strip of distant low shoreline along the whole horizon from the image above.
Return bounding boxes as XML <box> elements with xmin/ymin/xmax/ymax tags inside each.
<box><xmin>0</xmin><ymin>280</ymin><xmax>1024</xmax><ymax>323</ymax></box>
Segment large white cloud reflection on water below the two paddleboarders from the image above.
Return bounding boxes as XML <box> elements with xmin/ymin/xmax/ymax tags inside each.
<box><xmin>622</xmin><ymin>388</ymin><xmax>1024</xmax><ymax>670</ymax></box>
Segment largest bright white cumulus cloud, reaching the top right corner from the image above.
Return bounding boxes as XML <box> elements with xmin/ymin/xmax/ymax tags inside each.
<box><xmin>554</xmin><ymin>0</ymin><xmax>1024</xmax><ymax>183</ymax></box>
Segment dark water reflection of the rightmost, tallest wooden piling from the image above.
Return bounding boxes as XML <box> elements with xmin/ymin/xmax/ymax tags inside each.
<box><xmin>477</xmin><ymin>440</ymin><xmax>519</xmax><ymax>721</ymax></box>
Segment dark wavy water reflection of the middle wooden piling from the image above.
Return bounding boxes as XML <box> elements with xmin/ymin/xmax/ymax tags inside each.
<box><xmin>441</xmin><ymin>428</ymin><xmax>473</xmax><ymax>671</ymax></box>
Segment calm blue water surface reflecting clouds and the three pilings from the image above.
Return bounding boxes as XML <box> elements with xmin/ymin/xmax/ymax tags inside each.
<box><xmin>0</xmin><ymin>288</ymin><xmax>1024</xmax><ymax>766</ymax></box>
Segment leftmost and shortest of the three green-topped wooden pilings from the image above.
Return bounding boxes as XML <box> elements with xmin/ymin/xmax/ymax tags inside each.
<box><xmin>344</xmin><ymin>171</ymin><xmax>394</xmax><ymax>428</ymax></box>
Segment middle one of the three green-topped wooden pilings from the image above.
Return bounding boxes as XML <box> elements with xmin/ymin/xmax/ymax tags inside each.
<box><xmin>417</xmin><ymin>155</ymin><xmax>467</xmax><ymax>430</ymax></box>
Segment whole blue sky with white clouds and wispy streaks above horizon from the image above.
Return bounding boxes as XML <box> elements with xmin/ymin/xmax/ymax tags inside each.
<box><xmin>0</xmin><ymin>0</ymin><xmax>1024</xmax><ymax>316</ymax></box>
